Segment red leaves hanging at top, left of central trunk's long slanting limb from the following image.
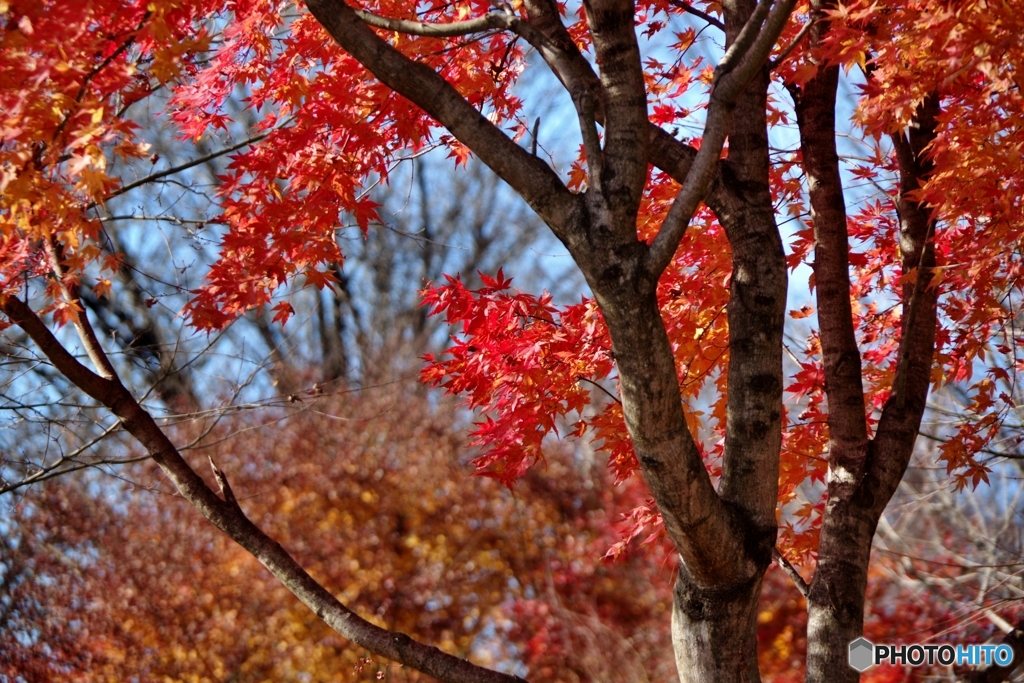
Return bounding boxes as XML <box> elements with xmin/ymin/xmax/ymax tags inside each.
<box><xmin>172</xmin><ymin>0</ymin><xmax>521</xmax><ymax>329</ymax></box>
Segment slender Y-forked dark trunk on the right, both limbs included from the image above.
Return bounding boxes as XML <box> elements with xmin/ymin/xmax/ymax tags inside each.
<box><xmin>791</xmin><ymin>0</ymin><xmax>938</xmax><ymax>683</ymax></box>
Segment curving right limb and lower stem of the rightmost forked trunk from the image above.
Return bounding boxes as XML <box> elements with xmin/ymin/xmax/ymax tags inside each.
<box><xmin>807</xmin><ymin>88</ymin><xmax>938</xmax><ymax>681</ymax></box>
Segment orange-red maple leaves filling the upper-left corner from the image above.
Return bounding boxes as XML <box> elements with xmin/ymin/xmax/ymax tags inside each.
<box><xmin>0</xmin><ymin>0</ymin><xmax>211</xmax><ymax>322</ymax></box>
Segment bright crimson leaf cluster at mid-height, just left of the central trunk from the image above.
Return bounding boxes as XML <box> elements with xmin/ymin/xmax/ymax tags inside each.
<box><xmin>423</xmin><ymin>270</ymin><xmax>610</xmax><ymax>486</ymax></box>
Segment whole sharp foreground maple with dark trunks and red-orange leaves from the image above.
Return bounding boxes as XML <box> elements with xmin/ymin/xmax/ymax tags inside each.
<box><xmin>0</xmin><ymin>0</ymin><xmax>1024</xmax><ymax>681</ymax></box>
